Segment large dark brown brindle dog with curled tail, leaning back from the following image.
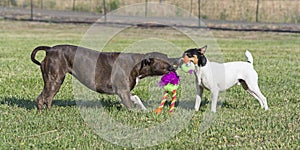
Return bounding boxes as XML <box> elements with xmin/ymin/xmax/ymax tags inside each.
<box><xmin>31</xmin><ymin>45</ymin><xmax>179</xmax><ymax>111</ymax></box>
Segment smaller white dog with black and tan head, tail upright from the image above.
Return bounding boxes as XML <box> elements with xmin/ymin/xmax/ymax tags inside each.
<box><xmin>183</xmin><ymin>46</ymin><xmax>268</xmax><ymax>112</ymax></box>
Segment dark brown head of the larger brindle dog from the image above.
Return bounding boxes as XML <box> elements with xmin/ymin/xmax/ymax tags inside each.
<box><xmin>138</xmin><ymin>58</ymin><xmax>175</xmax><ymax>78</ymax></box>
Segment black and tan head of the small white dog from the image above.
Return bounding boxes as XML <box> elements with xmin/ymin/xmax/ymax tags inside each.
<box><xmin>182</xmin><ymin>46</ymin><xmax>207</xmax><ymax>67</ymax></box>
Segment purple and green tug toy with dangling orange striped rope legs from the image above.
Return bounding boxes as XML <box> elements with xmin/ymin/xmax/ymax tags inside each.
<box><xmin>155</xmin><ymin>71</ymin><xmax>180</xmax><ymax>114</ymax></box>
